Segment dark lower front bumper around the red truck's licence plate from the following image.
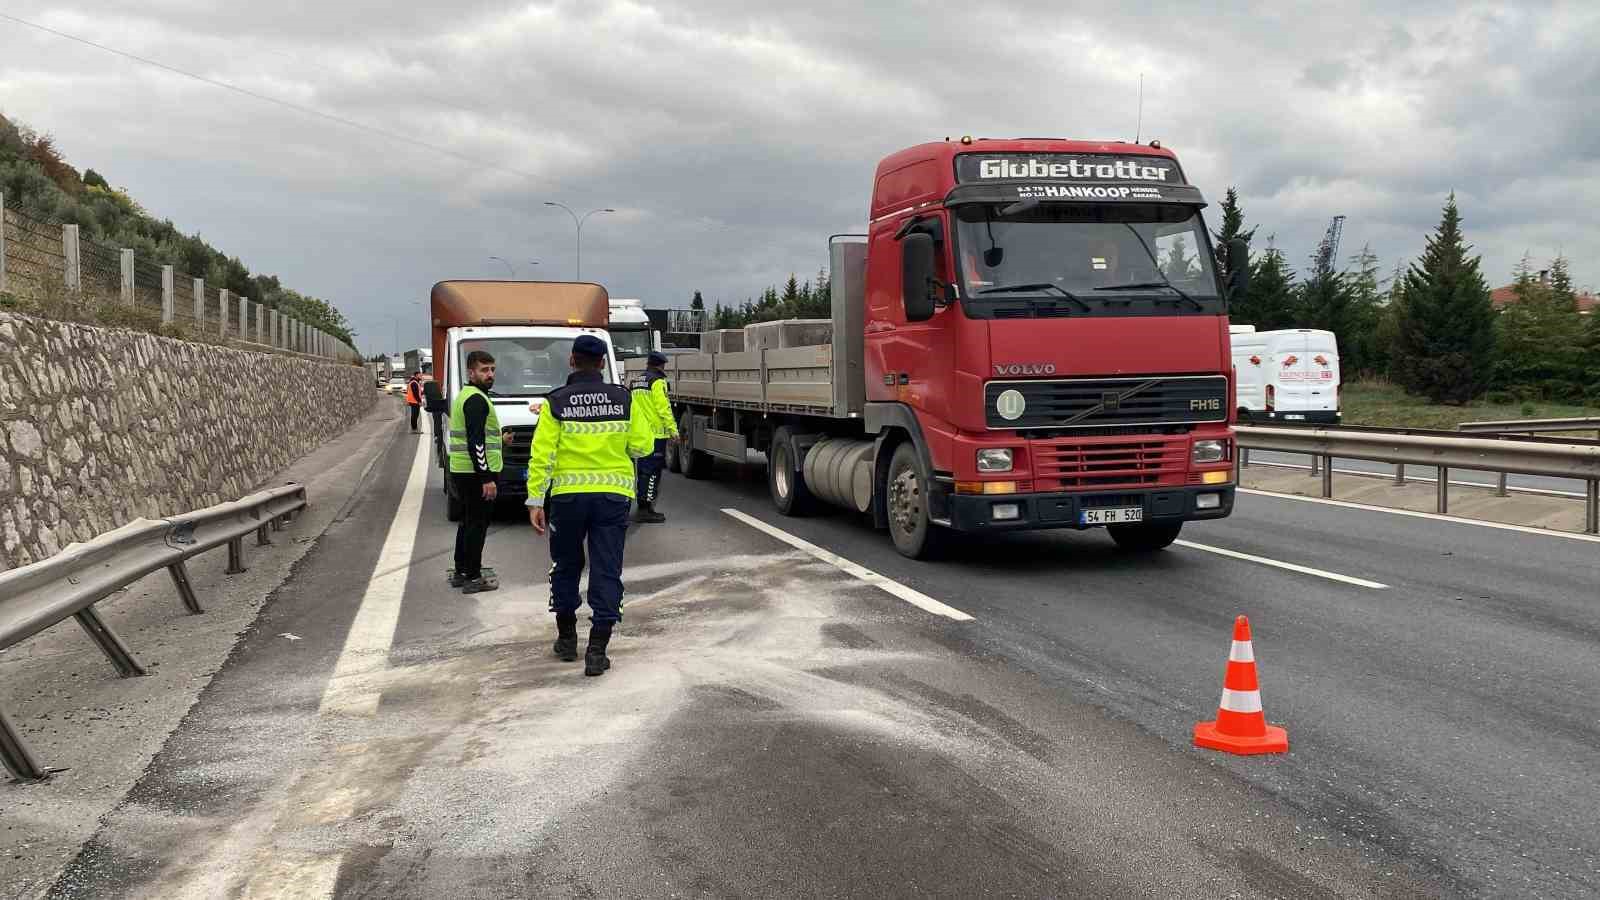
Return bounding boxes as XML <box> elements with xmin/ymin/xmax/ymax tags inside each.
<box><xmin>944</xmin><ymin>484</ymin><xmax>1235</xmax><ymax>532</ymax></box>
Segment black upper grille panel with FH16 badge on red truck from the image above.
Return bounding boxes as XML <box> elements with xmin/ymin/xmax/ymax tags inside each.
<box><xmin>984</xmin><ymin>375</ymin><xmax>1229</xmax><ymax>429</ymax></box>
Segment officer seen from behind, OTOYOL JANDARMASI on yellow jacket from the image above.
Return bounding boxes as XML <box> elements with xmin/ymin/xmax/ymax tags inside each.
<box><xmin>528</xmin><ymin>335</ymin><xmax>656</xmax><ymax>676</ymax></box>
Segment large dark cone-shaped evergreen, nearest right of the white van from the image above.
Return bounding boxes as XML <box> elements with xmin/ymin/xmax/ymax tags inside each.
<box><xmin>1394</xmin><ymin>192</ymin><xmax>1494</xmax><ymax>404</ymax></box>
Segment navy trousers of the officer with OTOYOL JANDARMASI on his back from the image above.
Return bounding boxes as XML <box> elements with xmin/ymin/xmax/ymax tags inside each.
<box><xmin>544</xmin><ymin>493</ymin><xmax>627</xmax><ymax>625</ymax></box>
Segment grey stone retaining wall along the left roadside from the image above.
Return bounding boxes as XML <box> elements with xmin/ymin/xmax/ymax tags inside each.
<box><xmin>0</xmin><ymin>314</ymin><xmax>378</xmax><ymax>569</ymax></box>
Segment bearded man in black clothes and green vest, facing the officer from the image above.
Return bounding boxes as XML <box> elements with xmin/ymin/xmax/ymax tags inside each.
<box><xmin>448</xmin><ymin>351</ymin><xmax>501</xmax><ymax>594</ymax></box>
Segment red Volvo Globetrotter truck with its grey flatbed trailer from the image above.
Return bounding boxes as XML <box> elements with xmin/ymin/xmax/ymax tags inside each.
<box><xmin>646</xmin><ymin>138</ymin><xmax>1246</xmax><ymax>559</ymax></box>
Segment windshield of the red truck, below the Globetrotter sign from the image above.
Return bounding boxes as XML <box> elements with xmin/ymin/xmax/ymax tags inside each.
<box><xmin>955</xmin><ymin>202</ymin><xmax>1226</xmax><ymax>319</ymax></box>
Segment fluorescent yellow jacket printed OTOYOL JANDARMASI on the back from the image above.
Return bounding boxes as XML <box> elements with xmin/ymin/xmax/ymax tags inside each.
<box><xmin>528</xmin><ymin>372</ymin><xmax>656</xmax><ymax>506</ymax></box>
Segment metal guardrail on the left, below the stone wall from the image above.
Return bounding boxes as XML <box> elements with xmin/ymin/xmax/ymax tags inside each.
<box><xmin>0</xmin><ymin>484</ymin><xmax>306</xmax><ymax>781</ymax></box>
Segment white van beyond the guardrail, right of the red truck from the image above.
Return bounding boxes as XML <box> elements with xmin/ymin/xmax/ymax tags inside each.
<box><xmin>1229</xmin><ymin>325</ymin><xmax>1341</xmax><ymax>424</ymax></box>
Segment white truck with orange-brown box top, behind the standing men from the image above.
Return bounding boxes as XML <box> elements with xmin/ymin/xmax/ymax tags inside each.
<box><xmin>424</xmin><ymin>280</ymin><xmax>616</xmax><ymax>522</ymax></box>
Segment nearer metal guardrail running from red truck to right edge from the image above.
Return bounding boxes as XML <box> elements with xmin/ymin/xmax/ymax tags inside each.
<box><xmin>1234</xmin><ymin>426</ymin><xmax>1600</xmax><ymax>533</ymax></box>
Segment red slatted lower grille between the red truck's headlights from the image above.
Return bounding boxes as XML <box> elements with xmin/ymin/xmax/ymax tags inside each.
<box><xmin>1030</xmin><ymin>436</ymin><xmax>1189</xmax><ymax>490</ymax></box>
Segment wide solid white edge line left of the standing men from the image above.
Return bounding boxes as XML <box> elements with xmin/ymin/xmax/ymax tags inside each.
<box><xmin>318</xmin><ymin>444</ymin><xmax>430</xmax><ymax>716</ymax></box>
